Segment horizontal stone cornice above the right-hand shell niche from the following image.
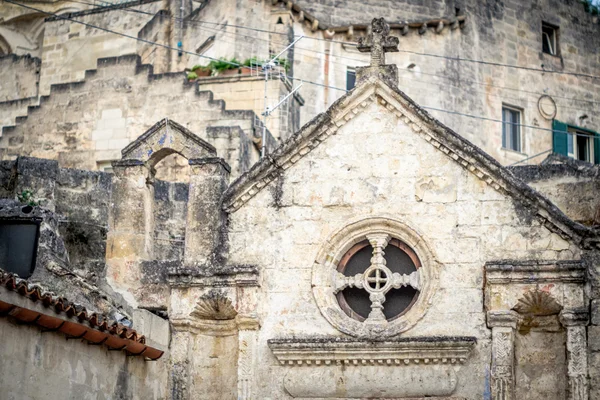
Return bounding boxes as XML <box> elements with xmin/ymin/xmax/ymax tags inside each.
<box><xmin>485</xmin><ymin>260</ymin><xmax>586</xmax><ymax>284</ymax></box>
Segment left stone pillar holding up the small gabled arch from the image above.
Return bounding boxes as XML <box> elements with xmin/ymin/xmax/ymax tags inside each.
<box><xmin>106</xmin><ymin>160</ymin><xmax>154</xmax><ymax>303</ymax></box>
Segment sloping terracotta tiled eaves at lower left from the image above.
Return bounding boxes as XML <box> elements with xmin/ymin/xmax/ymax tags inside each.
<box><xmin>0</xmin><ymin>270</ymin><xmax>164</xmax><ymax>360</ymax></box>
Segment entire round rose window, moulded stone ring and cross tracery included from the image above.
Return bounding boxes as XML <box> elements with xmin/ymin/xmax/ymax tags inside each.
<box><xmin>312</xmin><ymin>216</ymin><xmax>439</xmax><ymax>339</ymax></box>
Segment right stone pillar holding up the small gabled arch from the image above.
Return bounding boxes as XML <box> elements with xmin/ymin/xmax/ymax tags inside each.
<box><xmin>185</xmin><ymin>157</ymin><xmax>230</xmax><ymax>266</ymax></box>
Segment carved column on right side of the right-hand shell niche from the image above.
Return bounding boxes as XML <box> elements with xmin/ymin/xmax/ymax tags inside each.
<box><xmin>560</xmin><ymin>310</ymin><xmax>589</xmax><ymax>400</ymax></box>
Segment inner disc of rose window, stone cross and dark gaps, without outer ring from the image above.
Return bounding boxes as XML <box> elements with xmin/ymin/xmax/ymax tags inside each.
<box><xmin>336</xmin><ymin>235</ymin><xmax>421</xmax><ymax>322</ymax></box>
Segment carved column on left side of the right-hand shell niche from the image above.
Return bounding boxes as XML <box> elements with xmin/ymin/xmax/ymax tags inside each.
<box><xmin>487</xmin><ymin>311</ymin><xmax>519</xmax><ymax>400</ymax></box>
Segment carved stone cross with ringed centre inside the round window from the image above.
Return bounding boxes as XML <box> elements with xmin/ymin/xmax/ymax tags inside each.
<box><xmin>334</xmin><ymin>233</ymin><xmax>421</xmax><ymax>324</ymax></box>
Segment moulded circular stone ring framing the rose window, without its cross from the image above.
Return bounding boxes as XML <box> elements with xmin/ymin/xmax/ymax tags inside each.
<box><xmin>312</xmin><ymin>217</ymin><xmax>440</xmax><ymax>339</ymax></box>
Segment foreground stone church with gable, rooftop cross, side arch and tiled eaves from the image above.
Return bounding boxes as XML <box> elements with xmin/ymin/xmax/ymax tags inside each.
<box><xmin>0</xmin><ymin>19</ymin><xmax>600</xmax><ymax>400</ymax></box>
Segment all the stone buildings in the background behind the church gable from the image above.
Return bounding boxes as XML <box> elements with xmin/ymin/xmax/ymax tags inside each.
<box><xmin>0</xmin><ymin>0</ymin><xmax>600</xmax><ymax>177</ymax></box>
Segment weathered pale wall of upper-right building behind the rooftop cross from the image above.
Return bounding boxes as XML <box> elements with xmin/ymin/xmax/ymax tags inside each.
<box><xmin>275</xmin><ymin>0</ymin><xmax>600</xmax><ymax>165</ymax></box>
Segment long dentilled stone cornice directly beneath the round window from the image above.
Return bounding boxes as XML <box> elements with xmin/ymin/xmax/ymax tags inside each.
<box><xmin>268</xmin><ymin>336</ymin><xmax>477</xmax><ymax>366</ymax></box>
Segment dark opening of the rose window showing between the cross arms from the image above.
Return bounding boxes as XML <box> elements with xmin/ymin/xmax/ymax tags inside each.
<box><xmin>337</xmin><ymin>239</ymin><xmax>420</xmax><ymax>321</ymax></box>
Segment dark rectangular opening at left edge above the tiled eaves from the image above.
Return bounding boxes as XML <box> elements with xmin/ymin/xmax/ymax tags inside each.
<box><xmin>0</xmin><ymin>220</ymin><xmax>39</xmax><ymax>279</ymax></box>
